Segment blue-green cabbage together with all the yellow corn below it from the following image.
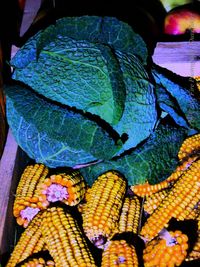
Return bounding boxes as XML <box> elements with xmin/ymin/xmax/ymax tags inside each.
<box><xmin>5</xmin><ymin>16</ymin><xmax>200</xmax><ymax>267</ymax></box>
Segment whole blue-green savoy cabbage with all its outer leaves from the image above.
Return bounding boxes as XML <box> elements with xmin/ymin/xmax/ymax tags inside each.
<box><xmin>4</xmin><ymin>16</ymin><xmax>200</xmax><ymax>185</ymax></box>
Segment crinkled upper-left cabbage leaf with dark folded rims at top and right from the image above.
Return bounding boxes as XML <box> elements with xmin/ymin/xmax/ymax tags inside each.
<box><xmin>12</xmin><ymin>16</ymin><xmax>147</xmax><ymax>125</ymax></box>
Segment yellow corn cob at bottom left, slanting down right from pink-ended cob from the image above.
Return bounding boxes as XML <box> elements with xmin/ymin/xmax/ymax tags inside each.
<box><xmin>41</xmin><ymin>207</ymin><xmax>96</xmax><ymax>267</ymax></box>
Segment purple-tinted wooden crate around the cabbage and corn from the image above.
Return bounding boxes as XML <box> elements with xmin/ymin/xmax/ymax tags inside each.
<box><xmin>0</xmin><ymin>42</ymin><xmax>200</xmax><ymax>266</ymax></box>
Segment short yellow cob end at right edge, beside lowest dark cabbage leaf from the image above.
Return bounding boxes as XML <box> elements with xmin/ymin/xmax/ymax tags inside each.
<box><xmin>178</xmin><ymin>134</ymin><xmax>200</xmax><ymax>160</ymax></box>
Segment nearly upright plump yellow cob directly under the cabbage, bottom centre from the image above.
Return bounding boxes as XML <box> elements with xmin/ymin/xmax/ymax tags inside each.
<box><xmin>82</xmin><ymin>171</ymin><xmax>127</xmax><ymax>248</ymax></box>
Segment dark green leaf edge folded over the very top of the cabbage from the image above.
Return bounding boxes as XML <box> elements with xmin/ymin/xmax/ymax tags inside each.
<box><xmin>37</xmin><ymin>16</ymin><xmax>148</xmax><ymax>64</ymax></box>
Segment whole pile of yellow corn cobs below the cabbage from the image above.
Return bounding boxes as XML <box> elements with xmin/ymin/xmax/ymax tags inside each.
<box><xmin>6</xmin><ymin>134</ymin><xmax>200</xmax><ymax>267</ymax></box>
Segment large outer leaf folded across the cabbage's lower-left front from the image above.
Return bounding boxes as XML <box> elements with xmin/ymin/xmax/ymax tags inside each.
<box><xmin>5</xmin><ymin>85</ymin><xmax>121</xmax><ymax>167</ymax></box>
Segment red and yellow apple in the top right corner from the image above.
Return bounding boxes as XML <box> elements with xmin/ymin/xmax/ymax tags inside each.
<box><xmin>164</xmin><ymin>8</ymin><xmax>200</xmax><ymax>35</ymax></box>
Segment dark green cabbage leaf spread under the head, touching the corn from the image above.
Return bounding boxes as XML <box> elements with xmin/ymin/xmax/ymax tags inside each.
<box><xmin>80</xmin><ymin>124</ymin><xmax>187</xmax><ymax>185</ymax></box>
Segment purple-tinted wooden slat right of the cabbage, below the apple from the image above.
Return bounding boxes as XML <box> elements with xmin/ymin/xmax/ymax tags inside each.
<box><xmin>153</xmin><ymin>39</ymin><xmax>200</xmax><ymax>77</ymax></box>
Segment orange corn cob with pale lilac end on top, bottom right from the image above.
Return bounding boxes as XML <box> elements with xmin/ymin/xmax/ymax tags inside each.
<box><xmin>143</xmin><ymin>230</ymin><xmax>188</xmax><ymax>267</ymax></box>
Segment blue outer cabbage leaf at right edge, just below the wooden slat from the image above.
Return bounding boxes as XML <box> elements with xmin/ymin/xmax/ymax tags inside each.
<box><xmin>152</xmin><ymin>65</ymin><xmax>200</xmax><ymax>130</ymax></box>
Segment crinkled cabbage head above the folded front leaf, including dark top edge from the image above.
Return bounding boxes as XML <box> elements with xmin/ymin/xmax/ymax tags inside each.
<box><xmin>12</xmin><ymin>16</ymin><xmax>157</xmax><ymax>154</ymax></box>
